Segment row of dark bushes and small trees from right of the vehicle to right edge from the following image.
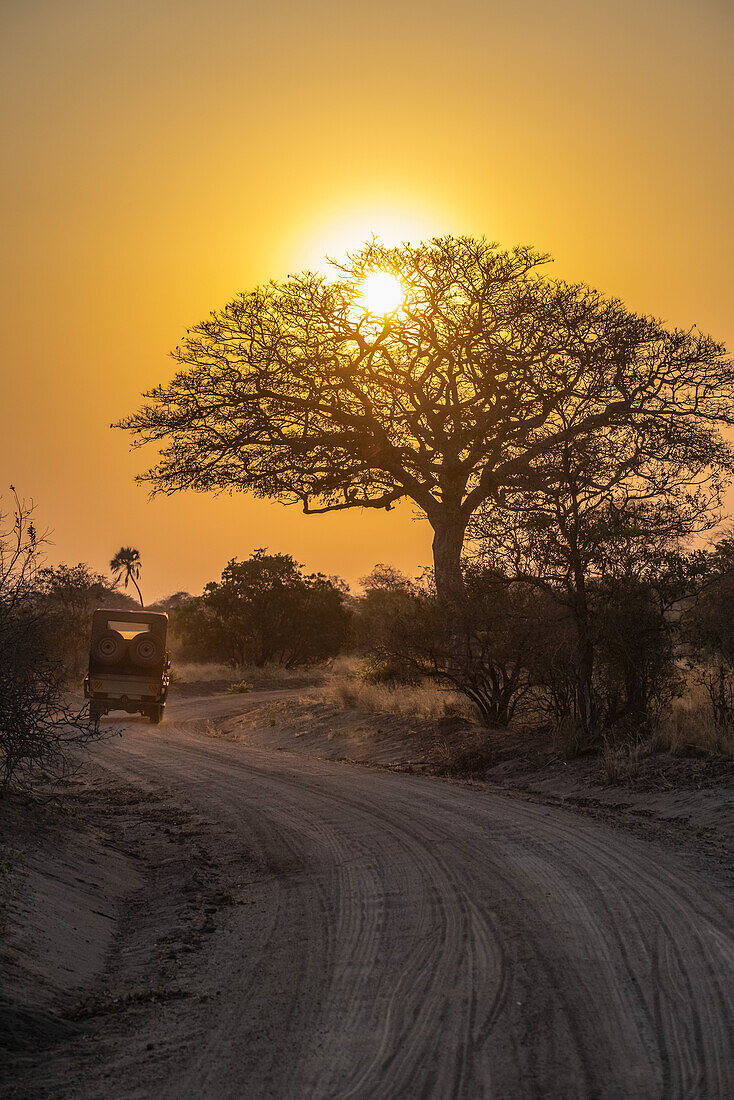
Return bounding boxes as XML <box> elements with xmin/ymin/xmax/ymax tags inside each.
<box><xmin>156</xmin><ymin>532</ymin><xmax>734</xmax><ymax>741</ymax></box>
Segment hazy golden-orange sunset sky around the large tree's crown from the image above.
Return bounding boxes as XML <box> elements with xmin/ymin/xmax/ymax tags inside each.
<box><xmin>0</xmin><ymin>0</ymin><xmax>734</xmax><ymax>600</ymax></box>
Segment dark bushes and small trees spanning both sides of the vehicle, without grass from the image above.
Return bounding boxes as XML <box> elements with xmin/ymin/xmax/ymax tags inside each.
<box><xmin>0</xmin><ymin>484</ymin><xmax>734</xmax><ymax>782</ymax></box>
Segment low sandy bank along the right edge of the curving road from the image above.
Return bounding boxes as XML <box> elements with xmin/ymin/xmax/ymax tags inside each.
<box><xmin>202</xmin><ymin>691</ymin><xmax>734</xmax><ymax>873</ymax></box>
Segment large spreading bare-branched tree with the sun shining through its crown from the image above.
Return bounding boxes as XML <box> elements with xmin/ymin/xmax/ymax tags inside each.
<box><xmin>122</xmin><ymin>237</ymin><xmax>734</xmax><ymax>597</ymax></box>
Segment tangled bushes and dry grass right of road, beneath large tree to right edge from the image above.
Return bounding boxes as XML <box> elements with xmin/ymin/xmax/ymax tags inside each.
<box><xmin>336</xmin><ymin>536</ymin><xmax>734</xmax><ymax>781</ymax></box>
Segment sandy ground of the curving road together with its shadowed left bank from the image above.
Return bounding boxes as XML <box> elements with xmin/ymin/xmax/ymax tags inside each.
<box><xmin>0</xmin><ymin>693</ymin><xmax>734</xmax><ymax>1098</ymax></box>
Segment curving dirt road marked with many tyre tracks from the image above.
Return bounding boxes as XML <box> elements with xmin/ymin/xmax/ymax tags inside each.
<box><xmin>4</xmin><ymin>697</ymin><xmax>734</xmax><ymax>1100</ymax></box>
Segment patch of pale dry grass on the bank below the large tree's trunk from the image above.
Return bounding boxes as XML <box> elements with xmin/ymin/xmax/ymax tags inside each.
<box><xmin>318</xmin><ymin>658</ymin><xmax>476</xmax><ymax>719</ymax></box>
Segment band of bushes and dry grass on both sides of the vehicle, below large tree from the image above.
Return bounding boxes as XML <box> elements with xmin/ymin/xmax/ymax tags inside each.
<box><xmin>5</xmin><ymin>481</ymin><xmax>734</xmax><ymax>787</ymax></box>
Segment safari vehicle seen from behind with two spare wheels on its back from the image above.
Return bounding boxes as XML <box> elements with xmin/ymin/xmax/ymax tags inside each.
<box><xmin>84</xmin><ymin>607</ymin><xmax>171</xmax><ymax>723</ymax></box>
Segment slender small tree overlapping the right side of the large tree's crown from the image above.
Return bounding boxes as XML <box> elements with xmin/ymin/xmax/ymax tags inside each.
<box><xmin>473</xmin><ymin>419</ymin><xmax>732</xmax><ymax>737</ymax></box>
